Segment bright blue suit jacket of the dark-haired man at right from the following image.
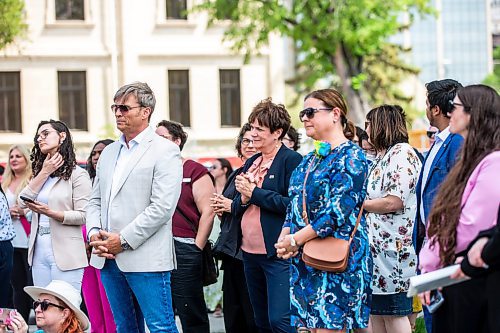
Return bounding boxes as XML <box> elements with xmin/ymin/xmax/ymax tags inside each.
<box><xmin>413</xmin><ymin>134</ymin><xmax>463</xmax><ymax>254</ymax></box>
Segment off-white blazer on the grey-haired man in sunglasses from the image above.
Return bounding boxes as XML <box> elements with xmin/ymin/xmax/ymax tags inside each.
<box><xmin>87</xmin><ymin>127</ymin><xmax>182</xmax><ymax>272</ymax></box>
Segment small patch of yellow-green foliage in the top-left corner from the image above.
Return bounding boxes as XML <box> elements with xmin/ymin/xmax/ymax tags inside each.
<box><xmin>0</xmin><ymin>0</ymin><xmax>27</xmax><ymax>49</ymax></box>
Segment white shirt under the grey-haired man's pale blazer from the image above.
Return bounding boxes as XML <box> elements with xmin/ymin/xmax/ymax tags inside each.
<box><xmin>107</xmin><ymin>128</ymin><xmax>147</xmax><ymax>231</ymax></box>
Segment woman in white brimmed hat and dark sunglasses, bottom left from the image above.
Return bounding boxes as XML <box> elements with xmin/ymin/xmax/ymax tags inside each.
<box><xmin>0</xmin><ymin>280</ymin><xmax>90</xmax><ymax>333</ymax></box>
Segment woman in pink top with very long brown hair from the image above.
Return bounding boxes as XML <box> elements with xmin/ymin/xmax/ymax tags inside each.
<box><xmin>419</xmin><ymin>85</ymin><xmax>500</xmax><ymax>333</ymax></box>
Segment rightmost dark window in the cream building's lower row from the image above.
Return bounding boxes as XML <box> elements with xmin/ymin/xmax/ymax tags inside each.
<box><xmin>219</xmin><ymin>69</ymin><xmax>241</xmax><ymax>127</ymax></box>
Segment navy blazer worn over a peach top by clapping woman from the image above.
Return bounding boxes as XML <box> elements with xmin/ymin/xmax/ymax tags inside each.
<box><xmin>233</xmin><ymin>145</ymin><xmax>302</xmax><ymax>257</ymax></box>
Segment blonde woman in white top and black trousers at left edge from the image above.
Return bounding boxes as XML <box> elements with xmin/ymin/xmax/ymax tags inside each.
<box><xmin>2</xmin><ymin>145</ymin><xmax>32</xmax><ymax>321</ymax></box>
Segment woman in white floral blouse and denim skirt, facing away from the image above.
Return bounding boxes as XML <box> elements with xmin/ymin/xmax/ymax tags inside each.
<box><xmin>365</xmin><ymin>105</ymin><xmax>422</xmax><ymax>333</ymax></box>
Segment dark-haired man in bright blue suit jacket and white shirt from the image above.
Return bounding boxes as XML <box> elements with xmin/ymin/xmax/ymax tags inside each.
<box><xmin>413</xmin><ymin>79</ymin><xmax>463</xmax><ymax>332</ymax></box>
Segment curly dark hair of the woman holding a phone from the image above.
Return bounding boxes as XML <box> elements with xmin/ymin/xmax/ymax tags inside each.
<box><xmin>30</xmin><ymin>119</ymin><xmax>76</xmax><ymax>180</ymax></box>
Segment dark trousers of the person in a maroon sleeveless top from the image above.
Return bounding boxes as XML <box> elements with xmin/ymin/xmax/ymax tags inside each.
<box><xmin>172</xmin><ymin>240</ymin><xmax>210</xmax><ymax>333</ymax></box>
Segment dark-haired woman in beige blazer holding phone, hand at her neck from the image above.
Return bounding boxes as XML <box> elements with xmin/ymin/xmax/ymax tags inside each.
<box><xmin>19</xmin><ymin>120</ymin><xmax>91</xmax><ymax>290</ymax></box>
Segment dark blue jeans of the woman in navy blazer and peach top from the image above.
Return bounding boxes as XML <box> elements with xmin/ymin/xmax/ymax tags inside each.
<box><xmin>243</xmin><ymin>252</ymin><xmax>295</xmax><ymax>333</ymax></box>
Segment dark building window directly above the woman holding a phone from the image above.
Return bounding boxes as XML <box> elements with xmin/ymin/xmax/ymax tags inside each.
<box><xmin>57</xmin><ymin>72</ymin><xmax>88</xmax><ymax>131</ymax></box>
